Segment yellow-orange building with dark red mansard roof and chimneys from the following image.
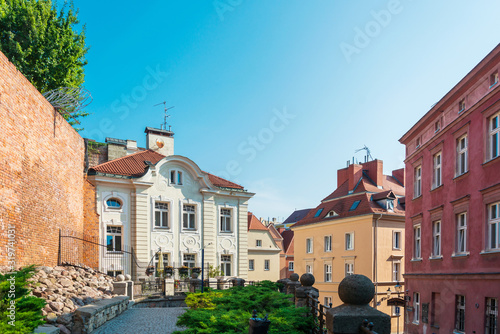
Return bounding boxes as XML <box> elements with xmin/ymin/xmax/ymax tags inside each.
<box><xmin>291</xmin><ymin>160</ymin><xmax>405</xmax><ymax>333</ymax></box>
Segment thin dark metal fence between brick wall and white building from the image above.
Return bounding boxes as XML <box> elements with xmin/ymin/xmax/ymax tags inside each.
<box><xmin>58</xmin><ymin>230</ymin><xmax>142</xmax><ymax>280</ymax></box>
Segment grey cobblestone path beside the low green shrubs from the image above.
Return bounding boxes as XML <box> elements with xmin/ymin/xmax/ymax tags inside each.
<box><xmin>92</xmin><ymin>307</ymin><xmax>186</xmax><ymax>334</ymax></box>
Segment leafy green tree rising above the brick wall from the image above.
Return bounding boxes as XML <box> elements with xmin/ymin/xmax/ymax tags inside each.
<box><xmin>0</xmin><ymin>0</ymin><xmax>88</xmax><ymax>129</ymax></box>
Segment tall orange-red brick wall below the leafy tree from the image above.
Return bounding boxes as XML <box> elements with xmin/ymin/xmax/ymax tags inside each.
<box><xmin>0</xmin><ymin>52</ymin><xmax>84</xmax><ymax>265</ymax></box>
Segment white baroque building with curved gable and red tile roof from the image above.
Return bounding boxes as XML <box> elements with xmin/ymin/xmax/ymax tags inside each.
<box><xmin>88</xmin><ymin>128</ymin><xmax>254</xmax><ymax>279</ymax></box>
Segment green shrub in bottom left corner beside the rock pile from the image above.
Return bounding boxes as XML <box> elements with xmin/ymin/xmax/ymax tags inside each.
<box><xmin>0</xmin><ymin>265</ymin><xmax>46</xmax><ymax>333</ymax></box>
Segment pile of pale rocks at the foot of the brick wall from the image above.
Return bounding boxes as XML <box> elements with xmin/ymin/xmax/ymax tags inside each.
<box><xmin>30</xmin><ymin>266</ymin><xmax>118</xmax><ymax>333</ymax></box>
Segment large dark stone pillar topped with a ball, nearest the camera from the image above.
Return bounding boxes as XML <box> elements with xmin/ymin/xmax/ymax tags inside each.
<box><xmin>326</xmin><ymin>275</ymin><xmax>391</xmax><ymax>334</ymax></box>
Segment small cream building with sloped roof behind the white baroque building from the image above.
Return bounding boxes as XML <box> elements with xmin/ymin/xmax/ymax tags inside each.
<box><xmin>248</xmin><ymin>212</ymin><xmax>281</xmax><ymax>282</ymax></box>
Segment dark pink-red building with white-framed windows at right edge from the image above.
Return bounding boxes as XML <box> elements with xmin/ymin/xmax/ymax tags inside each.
<box><xmin>400</xmin><ymin>45</ymin><xmax>500</xmax><ymax>334</ymax></box>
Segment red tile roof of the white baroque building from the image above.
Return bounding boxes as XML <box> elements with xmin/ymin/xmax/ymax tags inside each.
<box><xmin>89</xmin><ymin>150</ymin><xmax>244</xmax><ymax>190</ymax></box>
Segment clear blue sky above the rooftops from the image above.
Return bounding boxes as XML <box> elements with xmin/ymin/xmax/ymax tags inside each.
<box><xmin>75</xmin><ymin>0</ymin><xmax>500</xmax><ymax>219</ymax></box>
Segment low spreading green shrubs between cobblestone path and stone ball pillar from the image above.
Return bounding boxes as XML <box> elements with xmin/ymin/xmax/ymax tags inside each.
<box><xmin>176</xmin><ymin>281</ymin><xmax>313</xmax><ymax>334</ymax></box>
